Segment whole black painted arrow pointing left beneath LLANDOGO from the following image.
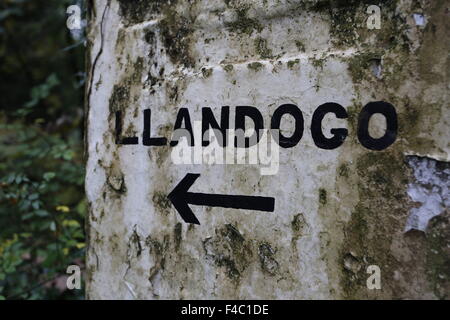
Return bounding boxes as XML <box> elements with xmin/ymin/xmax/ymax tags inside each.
<box><xmin>168</xmin><ymin>173</ymin><xmax>275</xmax><ymax>224</ymax></box>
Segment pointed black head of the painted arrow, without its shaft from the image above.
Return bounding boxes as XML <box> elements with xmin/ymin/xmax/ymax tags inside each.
<box><xmin>167</xmin><ymin>173</ymin><xmax>200</xmax><ymax>224</ymax></box>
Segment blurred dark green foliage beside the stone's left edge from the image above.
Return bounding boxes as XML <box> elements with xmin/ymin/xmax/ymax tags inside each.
<box><xmin>0</xmin><ymin>0</ymin><xmax>86</xmax><ymax>299</ymax></box>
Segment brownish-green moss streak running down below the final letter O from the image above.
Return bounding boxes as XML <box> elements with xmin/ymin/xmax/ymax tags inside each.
<box><xmin>340</xmin><ymin>149</ymin><xmax>408</xmax><ymax>298</ymax></box>
